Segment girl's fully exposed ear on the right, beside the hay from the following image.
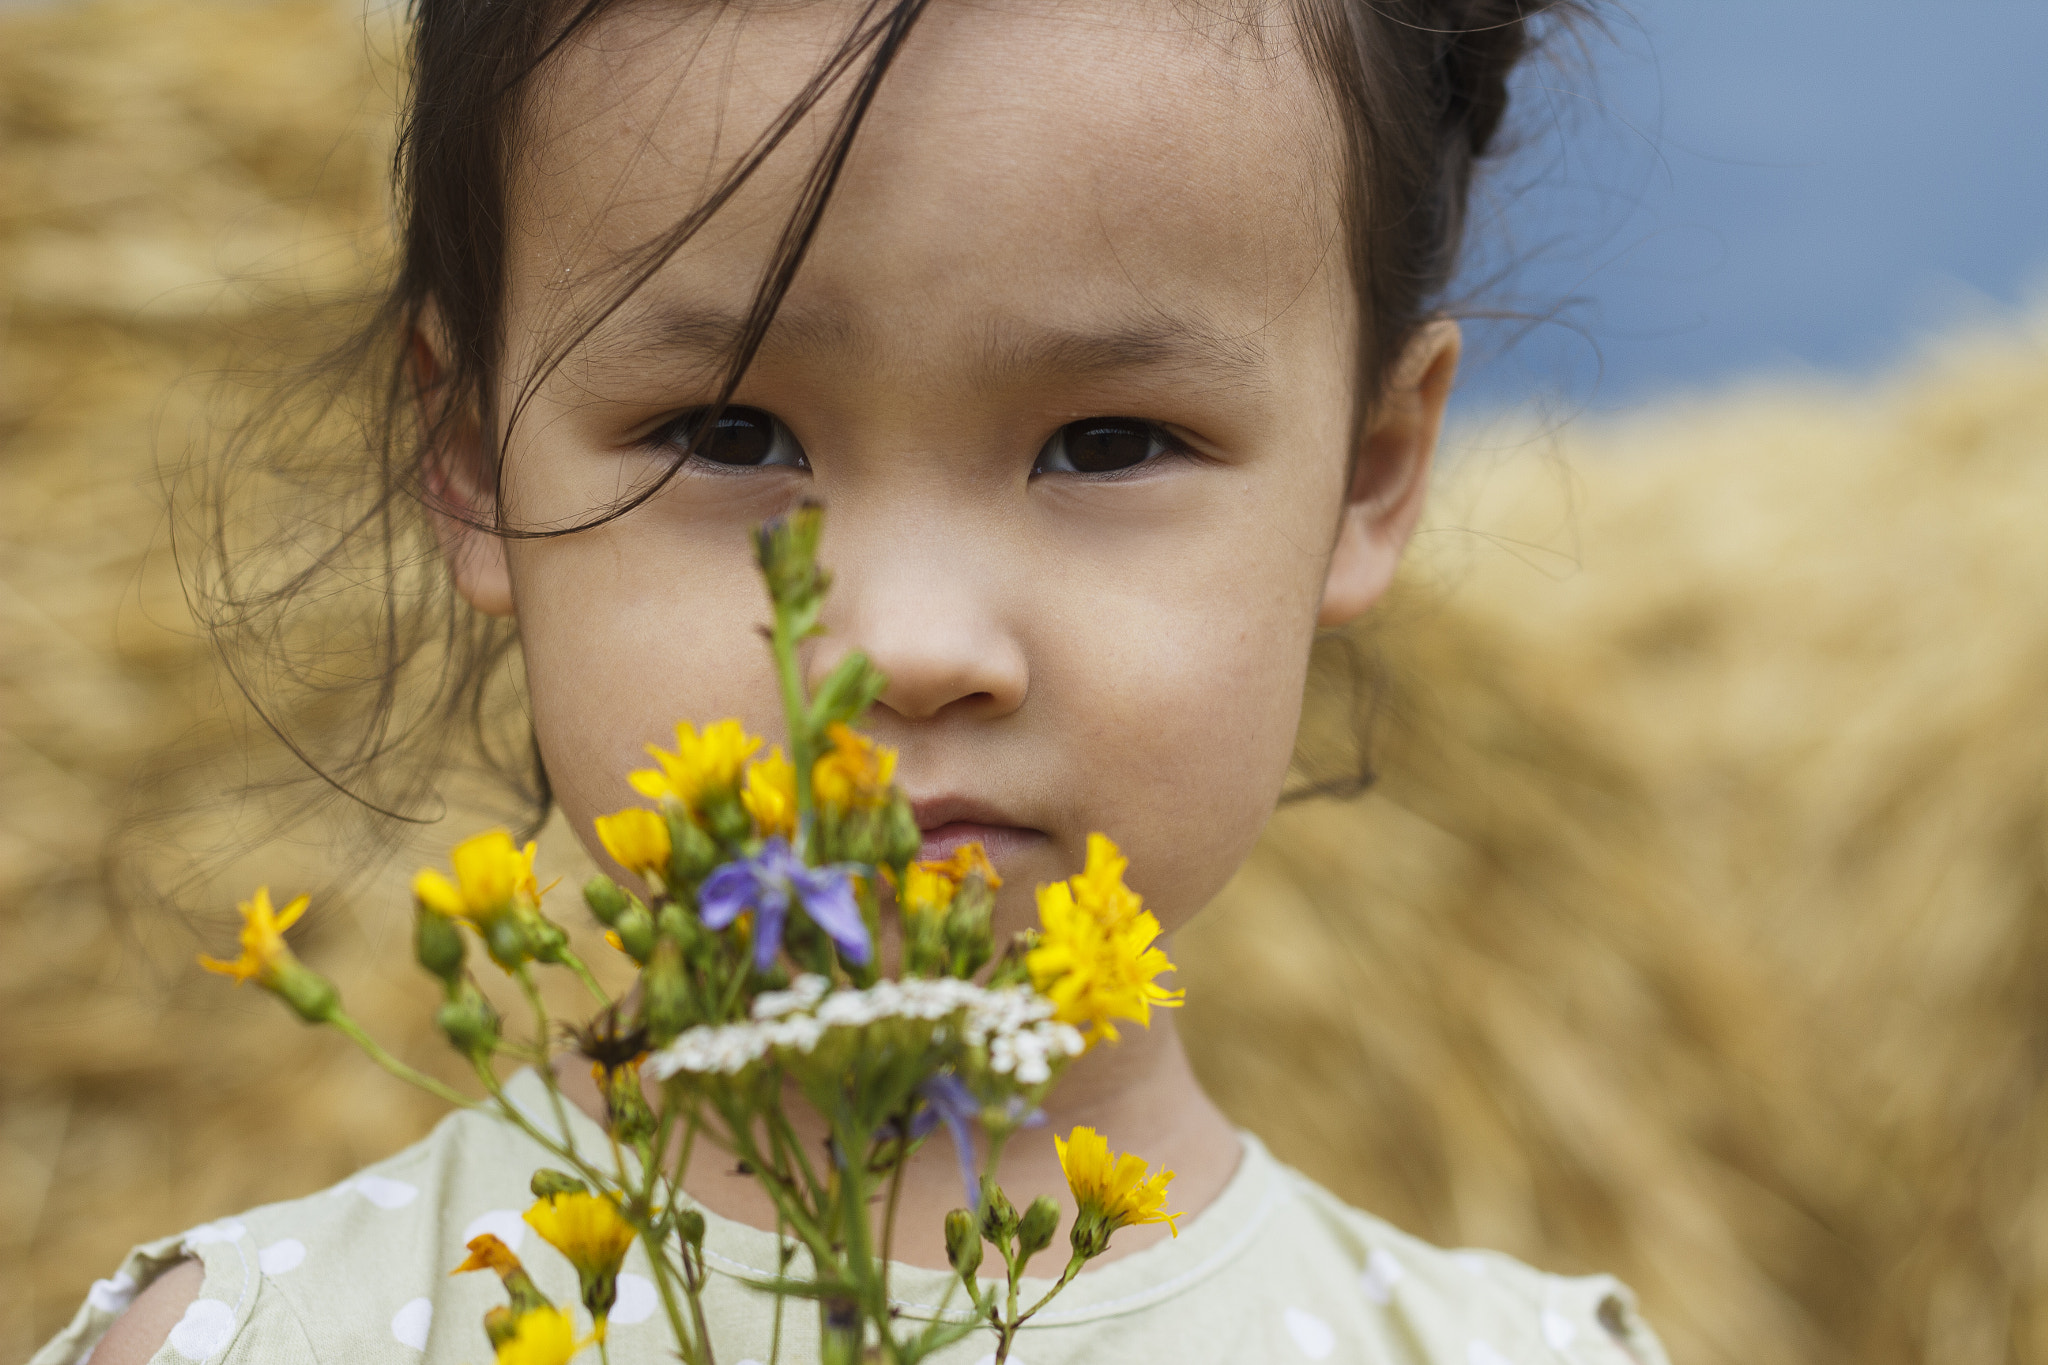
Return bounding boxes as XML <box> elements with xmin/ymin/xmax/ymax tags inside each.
<box><xmin>1315</xmin><ymin>317</ymin><xmax>1464</xmax><ymax>626</ymax></box>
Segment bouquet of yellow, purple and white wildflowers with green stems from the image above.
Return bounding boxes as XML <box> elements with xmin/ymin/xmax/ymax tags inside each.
<box><xmin>201</xmin><ymin>505</ymin><xmax>1180</xmax><ymax>1365</ymax></box>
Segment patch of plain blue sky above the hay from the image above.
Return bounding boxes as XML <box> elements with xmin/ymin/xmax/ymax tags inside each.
<box><xmin>1464</xmin><ymin>0</ymin><xmax>2048</xmax><ymax>411</ymax></box>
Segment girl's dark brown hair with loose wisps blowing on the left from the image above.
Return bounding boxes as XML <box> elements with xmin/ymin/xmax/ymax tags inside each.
<box><xmin>184</xmin><ymin>0</ymin><xmax>1581</xmax><ymax>871</ymax></box>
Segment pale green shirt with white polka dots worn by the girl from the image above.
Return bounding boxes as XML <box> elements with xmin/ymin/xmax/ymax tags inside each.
<box><xmin>31</xmin><ymin>1072</ymin><xmax>1665</xmax><ymax>1365</ymax></box>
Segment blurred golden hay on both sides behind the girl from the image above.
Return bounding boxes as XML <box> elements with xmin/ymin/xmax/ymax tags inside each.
<box><xmin>0</xmin><ymin>0</ymin><xmax>2048</xmax><ymax>1365</ymax></box>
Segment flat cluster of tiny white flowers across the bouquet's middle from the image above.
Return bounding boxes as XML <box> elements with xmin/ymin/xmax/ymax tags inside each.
<box><xmin>641</xmin><ymin>974</ymin><xmax>1087</xmax><ymax>1085</ymax></box>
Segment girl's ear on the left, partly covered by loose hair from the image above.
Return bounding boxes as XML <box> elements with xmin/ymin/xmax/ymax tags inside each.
<box><xmin>408</xmin><ymin>305</ymin><xmax>512</xmax><ymax>616</ymax></box>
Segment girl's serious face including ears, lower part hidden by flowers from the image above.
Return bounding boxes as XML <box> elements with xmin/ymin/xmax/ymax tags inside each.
<box><xmin>449</xmin><ymin>0</ymin><xmax>1456</xmax><ymax>929</ymax></box>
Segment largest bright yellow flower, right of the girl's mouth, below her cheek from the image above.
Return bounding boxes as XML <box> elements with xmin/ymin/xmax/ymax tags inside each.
<box><xmin>1024</xmin><ymin>835</ymin><xmax>1184</xmax><ymax>1046</ymax></box>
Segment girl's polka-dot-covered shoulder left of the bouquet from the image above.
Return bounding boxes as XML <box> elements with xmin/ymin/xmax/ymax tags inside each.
<box><xmin>31</xmin><ymin>1088</ymin><xmax>569</xmax><ymax>1365</ymax></box>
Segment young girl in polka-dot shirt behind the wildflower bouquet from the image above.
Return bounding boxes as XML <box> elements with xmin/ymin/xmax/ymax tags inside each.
<box><xmin>37</xmin><ymin>0</ymin><xmax>1663</xmax><ymax>1365</ymax></box>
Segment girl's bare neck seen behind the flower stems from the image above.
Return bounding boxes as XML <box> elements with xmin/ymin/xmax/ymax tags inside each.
<box><xmin>557</xmin><ymin>1011</ymin><xmax>1241</xmax><ymax>1275</ymax></box>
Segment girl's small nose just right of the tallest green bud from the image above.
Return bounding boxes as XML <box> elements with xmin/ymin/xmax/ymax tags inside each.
<box><xmin>811</xmin><ymin>551</ymin><xmax>1030</xmax><ymax>720</ymax></box>
